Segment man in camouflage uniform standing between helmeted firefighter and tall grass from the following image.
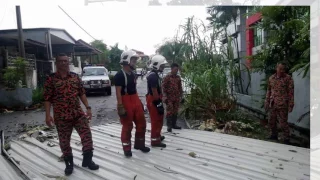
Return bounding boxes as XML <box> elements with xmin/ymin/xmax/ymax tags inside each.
<box><xmin>162</xmin><ymin>63</ymin><xmax>183</xmax><ymax>132</ymax></box>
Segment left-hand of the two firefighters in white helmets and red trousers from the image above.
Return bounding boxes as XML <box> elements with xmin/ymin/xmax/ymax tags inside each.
<box><xmin>114</xmin><ymin>50</ymin><xmax>150</xmax><ymax>157</ymax></box>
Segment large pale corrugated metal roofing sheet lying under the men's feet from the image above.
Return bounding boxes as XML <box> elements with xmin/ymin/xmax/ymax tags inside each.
<box><xmin>5</xmin><ymin>123</ymin><xmax>310</xmax><ymax>180</ymax></box>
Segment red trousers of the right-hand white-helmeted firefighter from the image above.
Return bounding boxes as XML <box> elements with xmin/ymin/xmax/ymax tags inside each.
<box><xmin>147</xmin><ymin>95</ymin><xmax>164</xmax><ymax>145</ymax></box>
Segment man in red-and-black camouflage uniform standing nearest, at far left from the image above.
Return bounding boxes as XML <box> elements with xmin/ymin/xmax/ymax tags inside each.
<box><xmin>44</xmin><ymin>54</ymin><xmax>99</xmax><ymax>175</ymax></box>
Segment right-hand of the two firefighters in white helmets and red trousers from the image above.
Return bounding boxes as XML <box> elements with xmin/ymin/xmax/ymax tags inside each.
<box><xmin>146</xmin><ymin>55</ymin><xmax>168</xmax><ymax>148</ymax></box>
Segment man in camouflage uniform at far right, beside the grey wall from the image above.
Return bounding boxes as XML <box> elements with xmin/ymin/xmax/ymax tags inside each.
<box><xmin>265</xmin><ymin>62</ymin><xmax>294</xmax><ymax>144</ymax></box>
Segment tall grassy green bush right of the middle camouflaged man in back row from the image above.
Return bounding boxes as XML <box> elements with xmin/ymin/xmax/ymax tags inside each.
<box><xmin>182</xmin><ymin>61</ymin><xmax>235</xmax><ymax>118</ymax></box>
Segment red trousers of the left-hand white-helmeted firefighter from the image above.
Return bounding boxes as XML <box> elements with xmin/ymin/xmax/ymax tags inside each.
<box><xmin>120</xmin><ymin>94</ymin><xmax>147</xmax><ymax>151</ymax></box>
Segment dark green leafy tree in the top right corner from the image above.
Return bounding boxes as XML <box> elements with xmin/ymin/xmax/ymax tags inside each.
<box><xmin>252</xmin><ymin>6</ymin><xmax>310</xmax><ymax>77</ymax></box>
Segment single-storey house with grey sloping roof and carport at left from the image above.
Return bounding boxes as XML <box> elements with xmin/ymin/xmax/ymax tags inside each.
<box><xmin>0</xmin><ymin>28</ymin><xmax>102</xmax><ymax>88</ymax></box>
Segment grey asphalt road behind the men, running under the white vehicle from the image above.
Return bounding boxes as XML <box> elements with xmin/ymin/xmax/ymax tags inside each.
<box><xmin>0</xmin><ymin>78</ymin><xmax>187</xmax><ymax>139</ymax></box>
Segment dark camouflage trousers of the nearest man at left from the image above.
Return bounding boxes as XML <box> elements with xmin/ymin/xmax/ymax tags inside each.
<box><xmin>55</xmin><ymin>116</ymin><xmax>93</xmax><ymax>156</ymax></box>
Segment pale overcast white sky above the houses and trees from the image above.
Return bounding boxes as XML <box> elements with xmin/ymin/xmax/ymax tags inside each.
<box><xmin>0</xmin><ymin>0</ymin><xmax>207</xmax><ymax>54</ymax></box>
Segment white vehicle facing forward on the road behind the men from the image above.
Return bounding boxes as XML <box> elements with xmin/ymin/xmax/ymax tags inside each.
<box><xmin>82</xmin><ymin>66</ymin><xmax>111</xmax><ymax>95</ymax></box>
